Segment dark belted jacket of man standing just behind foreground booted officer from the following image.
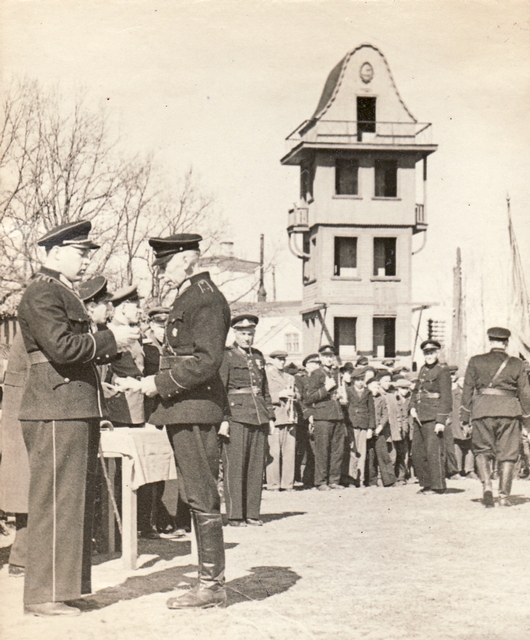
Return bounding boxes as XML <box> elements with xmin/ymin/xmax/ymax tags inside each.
<box><xmin>221</xmin><ymin>345</ymin><xmax>274</xmax><ymax>425</ymax></box>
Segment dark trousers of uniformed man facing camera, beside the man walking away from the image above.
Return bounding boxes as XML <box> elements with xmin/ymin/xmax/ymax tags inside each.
<box><xmin>412</xmin><ymin>420</ymin><xmax>446</xmax><ymax>490</ymax></box>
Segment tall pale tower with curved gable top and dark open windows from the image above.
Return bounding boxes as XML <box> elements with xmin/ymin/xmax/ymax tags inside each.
<box><xmin>282</xmin><ymin>44</ymin><xmax>436</xmax><ymax>360</ymax></box>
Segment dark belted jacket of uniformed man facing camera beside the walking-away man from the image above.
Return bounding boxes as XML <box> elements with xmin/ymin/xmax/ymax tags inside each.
<box><xmin>410</xmin><ymin>362</ymin><xmax>453</xmax><ymax>425</ymax></box>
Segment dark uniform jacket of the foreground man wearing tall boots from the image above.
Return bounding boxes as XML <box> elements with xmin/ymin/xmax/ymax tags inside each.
<box><xmin>149</xmin><ymin>272</ymin><xmax>230</xmax><ymax>425</ymax></box>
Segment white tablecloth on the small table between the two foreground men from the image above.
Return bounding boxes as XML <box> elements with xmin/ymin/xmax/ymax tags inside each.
<box><xmin>101</xmin><ymin>427</ymin><xmax>177</xmax><ymax>490</ymax></box>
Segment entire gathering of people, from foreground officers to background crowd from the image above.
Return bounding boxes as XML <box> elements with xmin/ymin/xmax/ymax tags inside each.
<box><xmin>0</xmin><ymin>222</ymin><xmax>530</xmax><ymax>616</ymax></box>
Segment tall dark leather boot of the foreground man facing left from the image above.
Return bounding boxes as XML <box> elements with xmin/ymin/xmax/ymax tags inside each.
<box><xmin>167</xmin><ymin>511</ymin><xmax>226</xmax><ymax>609</ymax></box>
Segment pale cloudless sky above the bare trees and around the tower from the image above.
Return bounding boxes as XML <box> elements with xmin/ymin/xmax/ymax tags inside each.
<box><xmin>0</xmin><ymin>0</ymin><xmax>530</xmax><ymax>356</ymax></box>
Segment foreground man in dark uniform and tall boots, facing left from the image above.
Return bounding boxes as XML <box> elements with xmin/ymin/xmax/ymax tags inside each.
<box><xmin>141</xmin><ymin>234</ymin><xmax>230</xmax><ymax>609</ymax></box>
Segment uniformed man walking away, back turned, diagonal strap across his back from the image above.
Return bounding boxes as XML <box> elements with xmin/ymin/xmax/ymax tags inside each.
<box><xmin>460</xmin><ymin>327</ymin><xmax>530</xmax><ymax>507</ymax></box>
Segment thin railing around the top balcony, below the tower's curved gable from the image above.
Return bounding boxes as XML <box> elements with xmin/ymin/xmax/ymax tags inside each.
<box><xmin>287</xmin><ymin>120</ymin><xmax>433</xmax><ymax>153</ymax></box>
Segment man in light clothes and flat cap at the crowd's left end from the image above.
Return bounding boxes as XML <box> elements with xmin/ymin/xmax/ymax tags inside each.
<box><xmin>266</xmin><ymin>351</ymin><xmax>298</xmax><ymax>491</ymax></box>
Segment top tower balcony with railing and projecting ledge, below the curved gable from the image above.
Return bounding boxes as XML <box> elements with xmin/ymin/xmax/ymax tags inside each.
<box><xmin>282</xmin><ymin>120</ymin><xmax>437</xmax><ymax>165</ymax></box>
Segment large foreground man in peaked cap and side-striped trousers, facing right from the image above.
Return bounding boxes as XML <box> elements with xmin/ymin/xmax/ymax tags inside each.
<box><xmin>18</xmin><ymin>222</ymin><xmax>139</xmax><ymax>616</ymax></box>
